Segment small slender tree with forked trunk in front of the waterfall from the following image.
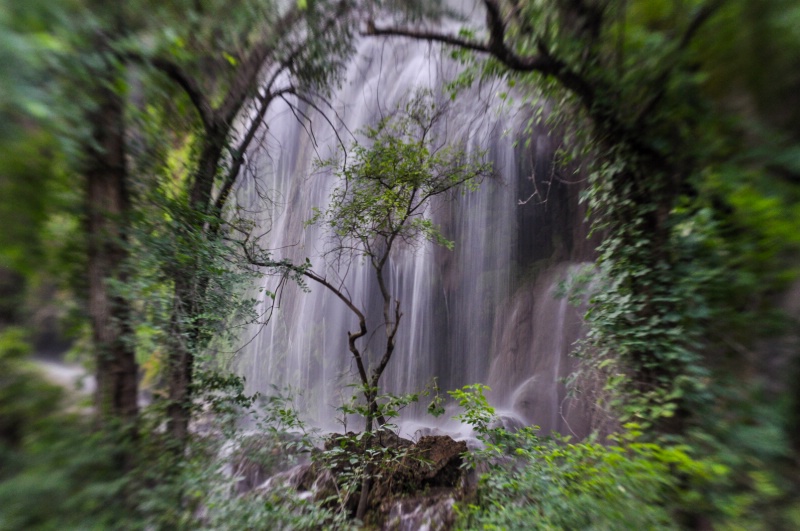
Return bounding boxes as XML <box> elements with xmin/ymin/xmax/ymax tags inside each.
<box><xmin>303</xmin><ymin>91</ymin><xmax>491</xmax><ymax>432</ymax></box>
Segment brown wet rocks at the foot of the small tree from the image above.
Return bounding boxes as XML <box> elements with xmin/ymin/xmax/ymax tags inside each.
<box><xmin>250</xmin><ymin>431</ymin><xmax>467</xmax><ymax>530</ymax></box>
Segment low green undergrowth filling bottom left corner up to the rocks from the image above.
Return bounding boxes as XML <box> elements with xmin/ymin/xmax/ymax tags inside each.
<box><xmin>0</xmin><ymin>366</ymin><xmax>347</xmax><ymax>530</ymax></box>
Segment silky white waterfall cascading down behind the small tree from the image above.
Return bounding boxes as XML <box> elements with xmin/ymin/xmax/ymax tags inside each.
<box><xmin>238</xmin><ymin>26</ymin><xmax>591</xmax><ymax>440</ymax></box>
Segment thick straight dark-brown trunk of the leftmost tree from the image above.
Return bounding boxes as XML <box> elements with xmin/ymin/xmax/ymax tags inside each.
<box><xmin>84</xmin><ymin>79</ymin><xmax>138</xmax><ymax>423</ymax></box>
